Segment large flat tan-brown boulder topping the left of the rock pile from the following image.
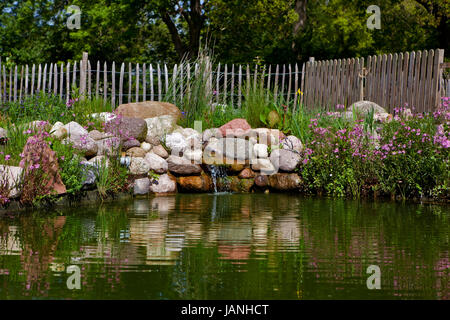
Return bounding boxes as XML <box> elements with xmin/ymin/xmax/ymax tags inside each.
<box><xmin>115</xmin><ymin>101</ymin><xmax>181</xmax><ymax>121</ymax></box>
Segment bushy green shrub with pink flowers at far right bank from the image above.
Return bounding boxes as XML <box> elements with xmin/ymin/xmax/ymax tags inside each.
<box><xmin>378</xmin><ymin>115</ymin><xmax>449</xmax><ymax>198</ymax></box>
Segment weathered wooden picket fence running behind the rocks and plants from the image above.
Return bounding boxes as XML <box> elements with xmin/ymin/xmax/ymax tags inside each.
<box><xmin>0</xmin><ymin>49</ymin><xmax>442</xmax><ymax>112</ymax></box>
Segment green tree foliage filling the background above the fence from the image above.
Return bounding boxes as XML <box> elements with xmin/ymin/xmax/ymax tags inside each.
<box><xmin>0</xmin><ymin>0</ymin><xmax>450</xmax><ymax>63</ymax></box>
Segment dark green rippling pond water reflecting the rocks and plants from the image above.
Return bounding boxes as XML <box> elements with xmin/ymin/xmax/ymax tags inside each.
<box><xmin>0</xmin><ymin>193</ymin><xmax>450</xmax><ymax>299</ymax></box>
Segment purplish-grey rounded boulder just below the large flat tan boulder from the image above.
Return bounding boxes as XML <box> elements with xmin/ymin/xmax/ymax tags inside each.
<box><xmin>105</xmin><ymin>117</ymin><xmax>147</xmax><ymax>142</ymax></box>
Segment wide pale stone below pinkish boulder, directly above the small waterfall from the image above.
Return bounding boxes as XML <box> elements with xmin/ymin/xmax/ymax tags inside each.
<box><xmin>204</xmin><ymin>138</ymin><xmax>254</xmax><ymax>160</ymax></box>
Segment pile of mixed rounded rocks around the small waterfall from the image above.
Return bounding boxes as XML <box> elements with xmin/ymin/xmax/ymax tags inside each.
<box><xmin>0</xmin><ymin>101</ymin><xmax>303</xmax><ymax>200</ymax></box>
